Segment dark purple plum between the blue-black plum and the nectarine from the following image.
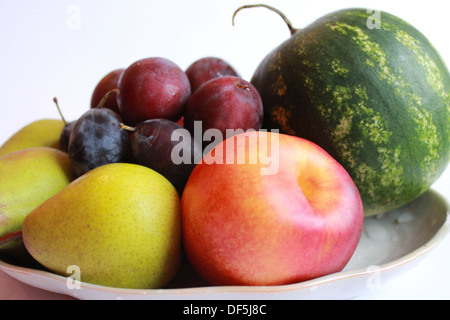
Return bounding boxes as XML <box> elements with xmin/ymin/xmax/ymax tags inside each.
<box><xmin>131</xmin><ymin>119</ymin><xmax>201</xmax><ymax>195</ymax></box>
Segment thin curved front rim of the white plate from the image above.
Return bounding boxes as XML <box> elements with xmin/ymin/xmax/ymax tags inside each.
<box><xmin>0</xmin><ymin>190</ymin><xmax>450</xmax><ymax>298</ymax></box>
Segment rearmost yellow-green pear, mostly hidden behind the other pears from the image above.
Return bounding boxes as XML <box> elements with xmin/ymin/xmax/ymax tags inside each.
<box><xmin>0</xmin><ymin>119</ymin><xmax>65</xmax><ymax>157</ymax></box>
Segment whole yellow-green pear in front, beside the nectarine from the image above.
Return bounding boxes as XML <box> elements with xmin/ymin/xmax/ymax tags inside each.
<box><xmin>22</xmin><ymin>163</ymin><xmax>181</xmax><ymax>289</ymax></box>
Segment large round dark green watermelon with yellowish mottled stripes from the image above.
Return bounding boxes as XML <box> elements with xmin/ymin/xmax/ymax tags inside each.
<box><xmin>251</xmin><ymin>9</ymin><xmax>450</xmax><ymax>216</ymax></box>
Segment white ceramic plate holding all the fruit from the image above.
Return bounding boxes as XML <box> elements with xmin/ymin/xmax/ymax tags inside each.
<box><xmin>0</xmin><ymin>190</ymin><xmax>450</xmax><ymax>300</ymax></box>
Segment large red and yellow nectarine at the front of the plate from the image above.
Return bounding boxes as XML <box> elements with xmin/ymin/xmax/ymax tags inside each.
<box><xmin>182</xmin><ymin>131</ymin><xmax>364</xmax><ymax>285</ymax></box>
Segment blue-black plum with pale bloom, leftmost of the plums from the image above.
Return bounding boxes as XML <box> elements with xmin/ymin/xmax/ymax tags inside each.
<box><xmin>68</xmin><ymin>108</ymin><xmax>130</xmax><ymax>177</ymax></box>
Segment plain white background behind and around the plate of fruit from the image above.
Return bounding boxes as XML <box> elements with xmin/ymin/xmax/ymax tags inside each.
<box><xmin>0</xmin><ymin>0</ymin><xmax>450</xmax><ymax>299</ymax></box>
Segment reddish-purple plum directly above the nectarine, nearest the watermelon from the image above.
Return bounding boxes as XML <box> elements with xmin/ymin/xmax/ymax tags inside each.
<box><xmin>184</xmin><ymin>76</ymin><xmax>263</xmax><ymax>142</ymax></box>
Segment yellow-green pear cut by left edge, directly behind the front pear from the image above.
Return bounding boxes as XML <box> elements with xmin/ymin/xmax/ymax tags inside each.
<box><xmin>0</xmin><ymin>147</ymin><xmax>74</xmax><ymax>249</ymax></box>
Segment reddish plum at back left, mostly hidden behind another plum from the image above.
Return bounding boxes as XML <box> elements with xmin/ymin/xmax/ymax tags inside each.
<box><xmin>91</xmin><ymin>69</ymin><xmax>125</xmax><ymax>114</ymax></box>
